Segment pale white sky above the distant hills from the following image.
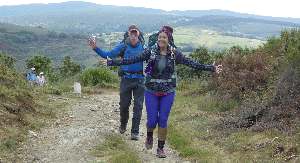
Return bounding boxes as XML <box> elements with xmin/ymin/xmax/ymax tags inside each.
<box><xmin>0</xmin><ymin>0</ymin><xmax>300</xmax><ymax>18</ymax></box>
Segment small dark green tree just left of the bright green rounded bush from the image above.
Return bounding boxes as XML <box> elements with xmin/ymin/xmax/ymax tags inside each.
<box><xmin>59</xmin><ymin>56</ymin><xmax>81</xmax><ymax>76</ymax></box>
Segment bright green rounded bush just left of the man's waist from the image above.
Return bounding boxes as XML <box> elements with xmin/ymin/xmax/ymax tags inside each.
<box><xmin>80</xmin><ymin>68</ymin><xmax>118</xmax><ymax>86</ymax></box>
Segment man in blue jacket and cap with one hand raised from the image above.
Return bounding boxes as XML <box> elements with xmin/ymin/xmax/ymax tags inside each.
<box><xmin>89</xmin><ymin>25</ymin><xmax>144</xmax><ymax>140</ymax></box>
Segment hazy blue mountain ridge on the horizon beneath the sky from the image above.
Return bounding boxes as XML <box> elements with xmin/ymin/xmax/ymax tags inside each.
<box><xmin>0</xmin><ymin>1</ymin><xmax>300</xmax><ymax>40</ymax></box>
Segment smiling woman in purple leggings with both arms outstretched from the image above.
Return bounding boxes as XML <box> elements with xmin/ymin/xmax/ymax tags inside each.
<box><xmin>108</xmin><ymin>26</ymin><xmax>222</xmax><ymax>158</ymax></box>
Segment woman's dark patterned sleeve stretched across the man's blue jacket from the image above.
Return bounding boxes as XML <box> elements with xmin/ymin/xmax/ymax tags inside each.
<box><xmin>108</xmin><ymin>49</ymin><xmax>151</xmax><ymax>66</ymax></box>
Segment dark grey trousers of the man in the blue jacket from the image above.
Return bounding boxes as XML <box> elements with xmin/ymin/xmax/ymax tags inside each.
<box><xmin>120</xmin><ymin>77</ymin><xmax>145</xmax><ymax>134</ymax></box>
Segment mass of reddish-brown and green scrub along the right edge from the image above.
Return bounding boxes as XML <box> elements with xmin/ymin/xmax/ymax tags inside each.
<box><xmin>215</xmin><ymin>29</ymin><xmax>300</xmax><ymax>133</ymax></box>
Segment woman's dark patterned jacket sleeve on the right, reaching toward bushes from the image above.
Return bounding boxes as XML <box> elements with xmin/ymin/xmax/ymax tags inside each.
<box><xmin>175</xmin><ymin>50</ymin><xmax>215</xmax><ymax>72</ymax></box>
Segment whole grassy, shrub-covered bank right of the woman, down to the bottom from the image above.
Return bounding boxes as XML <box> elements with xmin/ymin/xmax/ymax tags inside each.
<box><xmin>169</xmin><ymin>30</ymin><xmax>300</xmax><ymax>163</ymax></box>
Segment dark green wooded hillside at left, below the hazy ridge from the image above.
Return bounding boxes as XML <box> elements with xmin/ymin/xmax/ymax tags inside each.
<box><xmin>0</xmin><ymin>23</ymin><xmax>106</xmax><ymax>69</ymax></box>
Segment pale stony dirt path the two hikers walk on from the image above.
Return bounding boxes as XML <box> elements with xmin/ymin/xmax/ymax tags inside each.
<box><xmin>20</xmin><ymin>93</ymin><xmax>188</xmax><ymax>163</ymax></box>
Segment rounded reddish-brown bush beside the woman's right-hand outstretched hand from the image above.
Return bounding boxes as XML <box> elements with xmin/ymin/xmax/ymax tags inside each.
<box><xmin>210</xmin><ymin>48</ymin><xmax>273</xmax><ymax>100</ymax></box>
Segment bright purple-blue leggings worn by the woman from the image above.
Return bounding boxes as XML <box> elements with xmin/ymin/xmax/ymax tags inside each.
<box><xmin>145</xmin><ymin>91</ymin><xmax>175</xmax><ymax>128</ymax></box>
